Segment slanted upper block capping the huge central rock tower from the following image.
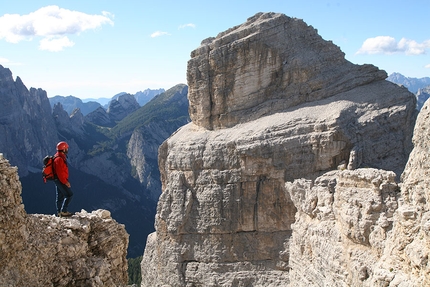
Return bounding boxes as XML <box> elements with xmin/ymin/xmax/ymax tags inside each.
<box><xmin>187</xmin><ymin>13</ymin><xmax>387</xmax><ymax>129</ymax></box>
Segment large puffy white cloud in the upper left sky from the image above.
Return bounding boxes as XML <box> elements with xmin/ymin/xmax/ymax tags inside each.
<box><xmin>0</xmin><ymin>5</ymin><xmax>113</xmax><ymax>51</ymax></box>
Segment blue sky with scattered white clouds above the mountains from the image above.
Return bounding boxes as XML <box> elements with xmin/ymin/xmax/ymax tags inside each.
<box><xmin>0</xmin><ymin>0</ymin><xmax>430</xmax><ymax>99</ymax></box>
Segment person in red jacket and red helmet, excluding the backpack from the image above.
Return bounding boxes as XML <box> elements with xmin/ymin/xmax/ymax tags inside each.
<box><xmin>54</xmin><ymin>141</ymin><xmax>73</xmax><ymax>217</ymax></box>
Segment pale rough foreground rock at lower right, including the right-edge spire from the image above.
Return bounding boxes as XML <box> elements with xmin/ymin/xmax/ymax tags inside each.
<box><xmin>286</xmin><ymin>97</ymin><xmax>430</xmax><ymax>286</ymax></box>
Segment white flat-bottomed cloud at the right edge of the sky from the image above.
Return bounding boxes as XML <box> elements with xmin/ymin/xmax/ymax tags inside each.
<box><xmin>357</xmin><ymin>36</ymin><xmax>430</xmax><ymax>55</ymax></box>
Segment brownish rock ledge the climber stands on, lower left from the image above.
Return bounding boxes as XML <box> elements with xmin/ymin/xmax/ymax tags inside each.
<box><xmin>0</xmin><ymin>154</ymin><xmax>128</xmax><ymax>287</ymax></box>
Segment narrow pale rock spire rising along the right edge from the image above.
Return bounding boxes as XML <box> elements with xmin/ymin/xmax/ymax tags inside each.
<box><xmin>384</xmin><ymin>101</ymin><xmax>430</xmax><ymax>286</ymax></box>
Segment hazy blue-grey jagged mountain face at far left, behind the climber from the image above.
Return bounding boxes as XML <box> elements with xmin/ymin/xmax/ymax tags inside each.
<box><xmin>0</xmin><ymin>65</ymin><xmax>58</xmax><ymax>176</ymax></box>
